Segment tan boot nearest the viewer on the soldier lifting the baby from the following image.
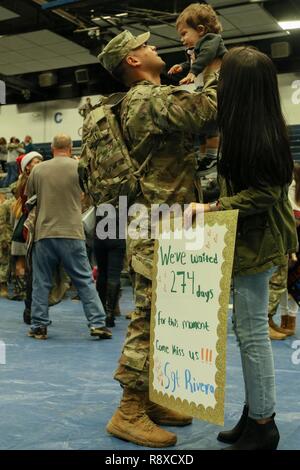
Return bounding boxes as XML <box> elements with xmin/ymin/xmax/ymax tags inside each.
<box><xmin>106</xmin><ymin>388</ymin><xmax>177</xmax><ymax>447</ymax></box>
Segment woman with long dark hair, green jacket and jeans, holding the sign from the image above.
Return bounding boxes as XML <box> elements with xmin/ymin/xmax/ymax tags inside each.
<box><xmin>186</xmin><ymin>47</ymin><xmax>297</xmax><ymax>450</ymax></box>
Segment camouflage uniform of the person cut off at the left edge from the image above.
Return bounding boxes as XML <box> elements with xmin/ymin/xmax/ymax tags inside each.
<box><xmin>0</xmin><ymin>198</ymin><xmax>13</xmax><ymax>284</ymax></box>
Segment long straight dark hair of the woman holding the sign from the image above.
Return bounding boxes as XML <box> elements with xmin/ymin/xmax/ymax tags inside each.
<box><xmin>218</xmin><ymin>47</ymin><xmax>293</xmax><ymax>191</ymax></box>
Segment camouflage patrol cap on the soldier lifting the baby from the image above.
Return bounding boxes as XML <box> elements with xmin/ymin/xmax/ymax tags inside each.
<box><xmin>98</xmin><ymin>30</ymin><xmax>150</xmax><ymax>73</ymax></box>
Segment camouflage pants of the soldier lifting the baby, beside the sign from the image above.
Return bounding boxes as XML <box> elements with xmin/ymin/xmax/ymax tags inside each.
<box><xmin>114</xmin><ymin>240</ymin><xmax>153</xmax><ymax>391</ymax></box>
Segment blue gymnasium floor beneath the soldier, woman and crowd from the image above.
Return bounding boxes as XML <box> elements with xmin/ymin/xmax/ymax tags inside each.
<box><xmin>0</xmin><ymin>286</ymin><xmax>300</xmax><ymax>450</ymax></box>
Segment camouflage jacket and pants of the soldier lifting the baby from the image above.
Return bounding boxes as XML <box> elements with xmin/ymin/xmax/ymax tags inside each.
<box><xmin>115</xmin><ymin>73</ymin><xmax>217</xmax><ymax>391</ymax></box>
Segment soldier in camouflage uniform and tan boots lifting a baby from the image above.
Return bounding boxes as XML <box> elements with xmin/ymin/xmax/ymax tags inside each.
<box><xmin>99</xmin><ymin>31</ymin><xmax>217</xmax><ymax>447</ymax></box>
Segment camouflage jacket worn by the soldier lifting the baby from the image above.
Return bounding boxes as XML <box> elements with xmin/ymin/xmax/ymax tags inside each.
<box><xmin>121</xmin><ymin>73</ymin><xmax>217</xmax><ymax>279</ymax></box>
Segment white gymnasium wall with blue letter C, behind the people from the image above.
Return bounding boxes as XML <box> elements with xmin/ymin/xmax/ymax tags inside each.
<box><xmin>0</xmin><ymin>73</ymin><xmax>300</xmax><ymax>143</ymax></box>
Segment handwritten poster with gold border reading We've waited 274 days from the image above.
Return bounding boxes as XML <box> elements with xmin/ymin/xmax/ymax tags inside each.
<box><xmin>150</xmin><ymin>211</ymin><xmax>238</xmax><ymax>425</ymax></box>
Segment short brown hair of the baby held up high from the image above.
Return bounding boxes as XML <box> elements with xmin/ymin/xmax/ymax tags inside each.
<box><xmin>176</xmin><ymin>3</ymin><xmax>222</xmax><ymax>34</ymax></box>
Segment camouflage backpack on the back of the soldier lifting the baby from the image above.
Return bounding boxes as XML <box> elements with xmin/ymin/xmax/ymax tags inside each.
<box><xmin>78</xmin><ymin>93</ymin><xmax>149</xmax><ymax>206</ymax></box>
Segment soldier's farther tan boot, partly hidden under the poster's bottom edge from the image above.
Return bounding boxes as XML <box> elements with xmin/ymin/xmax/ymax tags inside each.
<box><xmin>146</xmin><ymin>400</ymin><xmax>193</xmax><ymax>426</ymax></box>
